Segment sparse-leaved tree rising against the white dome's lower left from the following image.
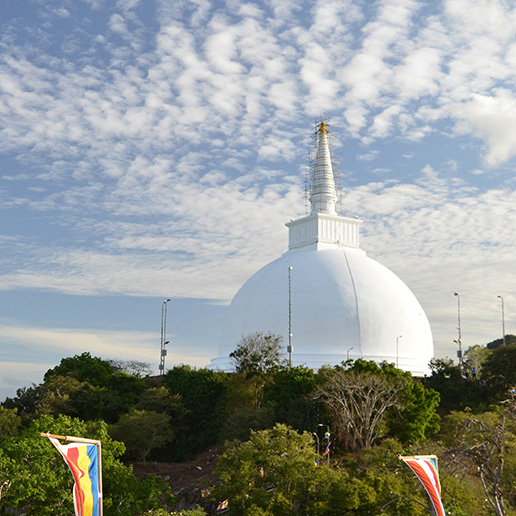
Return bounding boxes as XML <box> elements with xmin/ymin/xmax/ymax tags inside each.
<box><xmin>229</xmin><ymin>333</ymin><xmax>284</xmax><ymax>376</ymax></box>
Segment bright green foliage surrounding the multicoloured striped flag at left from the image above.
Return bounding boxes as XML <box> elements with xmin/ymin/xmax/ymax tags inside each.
<box><xmin>0</xmin><ymin>416</ymin><xmax>170</xmax><ymax>516</ymax></box>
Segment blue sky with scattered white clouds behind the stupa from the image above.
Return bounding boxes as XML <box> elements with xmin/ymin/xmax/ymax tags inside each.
<box><xmin>0</xmin><ymin>0</ymin><xmax>516</xmax><ymax>399</ymax></box>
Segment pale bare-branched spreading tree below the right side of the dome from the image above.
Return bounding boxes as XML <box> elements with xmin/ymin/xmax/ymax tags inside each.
<box><xmin>315</xmin><ymin>360</ymin><xmax>410</xmax><ymax>451</ymax></box>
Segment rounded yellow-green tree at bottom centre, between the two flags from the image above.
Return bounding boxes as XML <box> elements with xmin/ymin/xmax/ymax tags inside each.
<box><xmin>213</xmin><ymin>424</ymin><xmax>375</xmax><ymax>516</ymax></box>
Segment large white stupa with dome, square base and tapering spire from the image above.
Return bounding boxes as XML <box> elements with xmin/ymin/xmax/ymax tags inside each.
<box><xmin>210</xmin><ymin>122</ymin><xmax>434</xmax><ymax>376</ymax></box>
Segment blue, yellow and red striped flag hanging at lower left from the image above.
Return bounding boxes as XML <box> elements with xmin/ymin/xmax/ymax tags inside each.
<box><xmin>42</xmin><ymin>434</ymin><xmax>102</xmax><ymax>516</ymax></box>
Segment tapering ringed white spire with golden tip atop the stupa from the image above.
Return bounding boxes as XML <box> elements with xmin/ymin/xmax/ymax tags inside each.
<box><xmin>310</xmin><ymin>120</ymin><xmax>337</xmax><ymax>215</ymax></box>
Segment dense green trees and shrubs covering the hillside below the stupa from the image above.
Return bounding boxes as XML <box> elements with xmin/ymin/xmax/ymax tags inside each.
<box><xmin>0</xmin><ymin>334</ymin><xmax>516</xmax><ymax>516</ymax></box>
